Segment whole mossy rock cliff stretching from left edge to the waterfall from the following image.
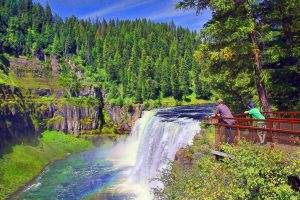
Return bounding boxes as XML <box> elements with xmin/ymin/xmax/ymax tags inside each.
<box><xmin>0</xmin><ymin>57</ymin><xmax>143</xmax><ymax>148</ymax></box>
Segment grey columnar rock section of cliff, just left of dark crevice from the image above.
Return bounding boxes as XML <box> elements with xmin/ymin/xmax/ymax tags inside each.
<box><xmin>32</xmin><ymin>87</ymin><xmax>105</xmax><ymax>135</ymax></box>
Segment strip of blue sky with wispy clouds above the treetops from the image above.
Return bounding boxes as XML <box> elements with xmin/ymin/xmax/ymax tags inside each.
<box><xmin>34</xmin><ymin>0</ymin><xmax>211</xmax><ymax>30</ymax></box>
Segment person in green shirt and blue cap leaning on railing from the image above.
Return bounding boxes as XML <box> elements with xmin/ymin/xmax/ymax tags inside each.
<box><xmin>244</xmin><ymin>103</ymin><xmax>266</xmax><ymax>145</ymax></box>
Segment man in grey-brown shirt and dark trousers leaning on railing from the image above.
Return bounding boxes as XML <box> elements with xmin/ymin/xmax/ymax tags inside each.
<box><xmin>214</xmin><ymin>99</ymin><xmax>235</xmax><ymax>144</ymax></box>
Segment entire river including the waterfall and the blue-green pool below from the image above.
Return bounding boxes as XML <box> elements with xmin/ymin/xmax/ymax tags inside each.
<box><xmin>14</xmin><ymin>106</ymin><xmax>211</xmax><ymax>200</ymax></box>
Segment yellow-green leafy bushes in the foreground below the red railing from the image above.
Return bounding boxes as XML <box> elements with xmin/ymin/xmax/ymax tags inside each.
<box><xmin>154</xmin><ymin>142</ymin><xmax>300</xmax><ymax>199</ymax></box>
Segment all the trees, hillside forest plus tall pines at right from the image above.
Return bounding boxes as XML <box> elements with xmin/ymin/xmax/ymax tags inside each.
<box><xmin>0</xmin><ymin>0</ymin><xmax>300</xmax><ymax>110</ymax></box>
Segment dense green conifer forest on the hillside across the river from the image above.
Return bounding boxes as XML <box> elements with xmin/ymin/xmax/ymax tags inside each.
<box><xmin>0</xmin><ymin>0</ymin><xmax>209</xmax><ymax>108</ymax></box>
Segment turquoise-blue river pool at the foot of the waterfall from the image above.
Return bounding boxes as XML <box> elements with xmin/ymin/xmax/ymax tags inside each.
<box><xmin>16</xmin><ymin>146</ymin><xmax>129</xmax><ymax>200</ymax></box>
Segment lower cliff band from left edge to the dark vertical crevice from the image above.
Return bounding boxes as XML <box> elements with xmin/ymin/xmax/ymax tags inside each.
<box><xmin>0</xmin><ymin>86</ymin><xmax>104</xmax><ymax>147</ymax></box>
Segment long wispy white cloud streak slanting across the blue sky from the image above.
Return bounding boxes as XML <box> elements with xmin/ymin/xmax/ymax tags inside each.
<box><xmin>80</xmin><ymin>0</ymin><xmax>154</xmax><ymax>19</ymax></box>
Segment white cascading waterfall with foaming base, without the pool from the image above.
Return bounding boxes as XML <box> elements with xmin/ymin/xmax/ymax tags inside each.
<box><xmin>110</xmin><ymin>110</ymin><xmax>200</xmax><ymax>200</ymax></box>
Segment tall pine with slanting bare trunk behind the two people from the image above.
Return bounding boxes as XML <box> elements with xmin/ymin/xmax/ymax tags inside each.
<box><xmin>177</xmin><ymin>0</ymin><xmax>278</xmax><ymax>111</ymax></box>
